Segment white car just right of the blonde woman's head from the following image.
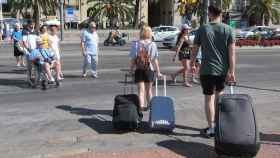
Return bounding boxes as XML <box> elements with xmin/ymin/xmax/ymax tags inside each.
<box><xmin>152</xmin><ymin>26</ymin><xmax>180</xmax><ymax>42</ymax></box>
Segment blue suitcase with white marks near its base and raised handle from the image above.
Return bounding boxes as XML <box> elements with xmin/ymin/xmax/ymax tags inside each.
<box><xmin>149</xmin><ymin>76</ymin><xmax>175</xmax><ymax>132</ymax></box>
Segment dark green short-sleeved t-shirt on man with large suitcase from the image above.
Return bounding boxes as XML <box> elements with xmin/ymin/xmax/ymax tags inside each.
<box><xmin>194</xmin><ymin>23</ymin><xmax>235</xmax><ymax>76</ymax></box>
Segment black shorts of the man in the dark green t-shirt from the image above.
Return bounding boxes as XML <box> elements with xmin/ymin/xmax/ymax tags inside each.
<box><xmin>200</xmin><ymin>75</ymin><xmax>226</xmax><ymax>95</ymax></box>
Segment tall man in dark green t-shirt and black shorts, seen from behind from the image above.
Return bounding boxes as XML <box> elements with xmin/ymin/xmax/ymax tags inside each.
<box><xmin>191</xmin><ymin>6</ymin><xmax>236</xmax><ymax>137</ymax></box>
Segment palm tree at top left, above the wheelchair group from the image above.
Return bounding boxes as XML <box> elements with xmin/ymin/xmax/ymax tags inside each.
<box><xmin>8</xmin><ymin>0</ymin><xmax>58</xmax><ymax>30</ymax></box>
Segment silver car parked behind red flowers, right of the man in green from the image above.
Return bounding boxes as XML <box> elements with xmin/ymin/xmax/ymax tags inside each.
<box><xmin>236</xmin><ymin>26</ymin><xmax>272</xmax><ymax>38</ymax></box>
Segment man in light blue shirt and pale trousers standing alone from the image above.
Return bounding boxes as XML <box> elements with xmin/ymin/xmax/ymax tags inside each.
<box><xmin>81</xmin><ymin>22</ymin><xmax>98</xmax><ymax>78</ymax></box>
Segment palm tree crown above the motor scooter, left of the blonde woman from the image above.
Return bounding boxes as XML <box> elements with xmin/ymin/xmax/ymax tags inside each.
<box><xmin>88</xmin><ymin>0</ymin><xmax>135</xmax><ymax>27</ymax></box>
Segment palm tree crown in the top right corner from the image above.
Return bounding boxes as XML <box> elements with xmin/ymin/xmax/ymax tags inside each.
<box><xmin>245</xmin><ymin>0</ymin><xmax>280</xmax><ymax>25</ymax></box>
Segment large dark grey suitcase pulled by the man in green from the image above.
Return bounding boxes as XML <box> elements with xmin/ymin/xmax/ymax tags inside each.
<box><xmin>215</xmin><ymin>86</ymin><xmax>260</xmax><ymax>157</ymax></box>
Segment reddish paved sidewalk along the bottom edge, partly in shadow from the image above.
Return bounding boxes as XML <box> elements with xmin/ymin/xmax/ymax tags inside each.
<box><xmin>35</xmin><ymin>133</ymin><xmax>280</xmax><ymax>158</ymax></box>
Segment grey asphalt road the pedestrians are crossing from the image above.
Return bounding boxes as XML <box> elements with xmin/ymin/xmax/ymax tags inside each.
<box><xmin>0</xmin><ymin>43</ymin><xmax>280</xmax><ymax>158</ymax></box>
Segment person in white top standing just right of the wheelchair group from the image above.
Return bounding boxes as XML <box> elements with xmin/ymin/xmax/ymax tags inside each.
<box><xmin>48</xmin><ymin>25</ymin><xmax>62</xmax><ymax>80</ymax></box>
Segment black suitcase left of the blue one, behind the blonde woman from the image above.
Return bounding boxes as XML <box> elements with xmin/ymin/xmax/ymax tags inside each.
<box><xmin>112</xmin><ymin>74</ymin><xmax>141</xmax><ymax>130</ymax></box>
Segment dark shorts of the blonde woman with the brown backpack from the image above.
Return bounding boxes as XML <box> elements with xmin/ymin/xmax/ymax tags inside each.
<box><xmin>135</xmin><ymin>69</ymin><xmax>155</xmax><ymax>83</ymax></box>
